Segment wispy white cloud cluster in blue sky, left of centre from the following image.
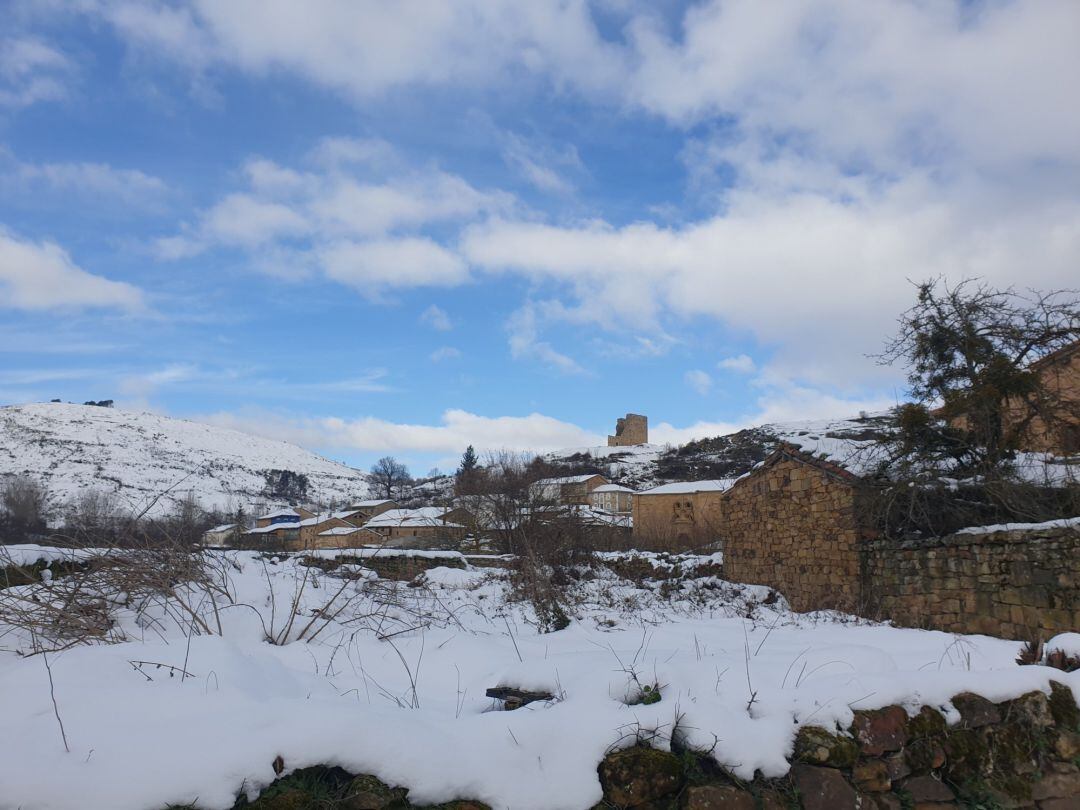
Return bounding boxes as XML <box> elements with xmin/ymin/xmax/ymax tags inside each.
<box><xmin>157</xmin><ymin>150</ymin><xmax>503</xmax><ymax>297</ymax></box>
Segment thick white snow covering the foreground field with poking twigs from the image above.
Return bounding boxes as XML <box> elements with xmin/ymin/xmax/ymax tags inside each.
<box><xmin>0</xmin><ymin>550</ymin><xmax>1080</xmax><ymax>810</ymax></box>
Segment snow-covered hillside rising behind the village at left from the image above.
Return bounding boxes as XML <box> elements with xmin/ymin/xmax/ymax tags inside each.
<box><xmin>0</xmin><ymin>403</ymin><xmax>367</xmax><ymax>511</ymax></box>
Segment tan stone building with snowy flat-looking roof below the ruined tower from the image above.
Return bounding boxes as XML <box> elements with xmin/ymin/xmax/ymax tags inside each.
<box><xmin>632</xmin><ymin>478</ymin><xmax>734</xmax><ymax>551</ymax></box>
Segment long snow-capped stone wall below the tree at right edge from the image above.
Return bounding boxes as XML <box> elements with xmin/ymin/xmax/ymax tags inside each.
<box><xmin>864</xmin><ymin>527</ymin><xmax>1080</xmax><ymax>639</ymax></box>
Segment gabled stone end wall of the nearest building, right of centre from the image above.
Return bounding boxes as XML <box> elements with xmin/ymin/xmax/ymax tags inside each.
<box><xmin>720</xmin><ymin>455</ymin><xmax>863</xmax><ymax>611</ymax></box>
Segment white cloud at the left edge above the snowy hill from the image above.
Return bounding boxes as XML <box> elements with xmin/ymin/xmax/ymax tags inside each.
<box><xmin>0</xmin><ymin>228</ymin><xmax>145</xmax><ymax>312</ymax></box>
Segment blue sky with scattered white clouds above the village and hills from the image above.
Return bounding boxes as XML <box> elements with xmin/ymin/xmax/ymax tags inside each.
<box><xmin>0</xmin><ymin>0</ymin><xmax>1080</xmax><ymax>474</ymax></box>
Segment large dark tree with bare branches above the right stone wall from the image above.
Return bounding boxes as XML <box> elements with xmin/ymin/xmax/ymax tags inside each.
<box><xmin>879</xmin><ymin>280</ymin><xmax>1080</xmax><ymax>470</ymax></box>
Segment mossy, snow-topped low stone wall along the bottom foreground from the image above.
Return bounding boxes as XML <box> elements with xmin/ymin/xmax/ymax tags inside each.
<box><xmin>237</xmin><ymin>681</ymin><xmax>1080</xmax><ymax>810</ymax></box>
